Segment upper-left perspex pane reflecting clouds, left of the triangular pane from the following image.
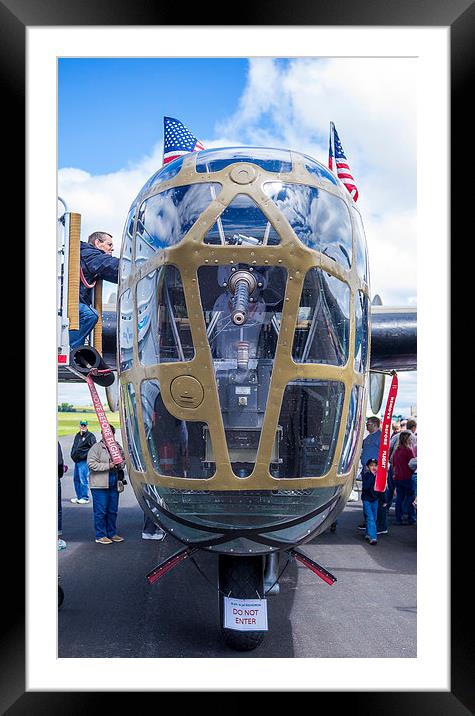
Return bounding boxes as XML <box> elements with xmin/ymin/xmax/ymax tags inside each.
<box><xmin>136</xmin><ymin>183</ymin><xmax>221</xmax><ymax>256</ymax></box>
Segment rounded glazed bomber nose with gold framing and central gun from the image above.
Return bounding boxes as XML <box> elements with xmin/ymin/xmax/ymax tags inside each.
<box><xmin>118</xmin><ymin>148</ymin><xmax>369</xmax><ymax>550</ymax></box>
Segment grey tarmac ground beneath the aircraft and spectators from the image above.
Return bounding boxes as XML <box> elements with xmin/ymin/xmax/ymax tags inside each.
<box><xmin>58</xmin><ymin>431</ymin><xmax>417</xmax><ymax>659</ymax></box>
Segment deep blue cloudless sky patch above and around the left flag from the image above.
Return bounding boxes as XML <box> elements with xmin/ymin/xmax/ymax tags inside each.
<box><xmin>58</xmin><ymin>58</ymin><xmax>248</xmax><ymax>174</ymax></box>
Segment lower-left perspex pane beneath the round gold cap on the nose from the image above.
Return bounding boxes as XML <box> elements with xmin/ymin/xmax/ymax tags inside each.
<box><xmin>140</xmin><ymin>380</ymin><xmax>216</xmax><ymax>479</ymax></box>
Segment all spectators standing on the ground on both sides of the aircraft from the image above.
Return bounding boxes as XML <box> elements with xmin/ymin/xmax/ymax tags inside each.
<box><xmin>58</xmin><ymin>416</ymin><xmax>417</xmax><ymax>549</ymax></box>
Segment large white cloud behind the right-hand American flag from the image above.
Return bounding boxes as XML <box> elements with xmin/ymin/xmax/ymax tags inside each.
<box><xmin>219</xmin><ymin>58</ymin><xmax>417</xmax><ymax>305</ymax></box>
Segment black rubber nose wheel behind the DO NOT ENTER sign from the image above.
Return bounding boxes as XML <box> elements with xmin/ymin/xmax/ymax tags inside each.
<box><xmin>218</xmin><ymin>554</ymin><xmax>265</xmax><ymax>651</ymax></box>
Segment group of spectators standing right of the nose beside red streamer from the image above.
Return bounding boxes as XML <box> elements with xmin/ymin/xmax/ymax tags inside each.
<box><xmin>358</xmin><ymin>416</ymin><xmax>417</xmax><ymax>545</ymax></box>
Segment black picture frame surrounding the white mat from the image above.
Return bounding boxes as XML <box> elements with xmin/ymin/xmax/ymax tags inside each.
<box><xmin>4</xmin><ymin>0</ymin><xmax>468</xmax><ymax>716</ymax></box>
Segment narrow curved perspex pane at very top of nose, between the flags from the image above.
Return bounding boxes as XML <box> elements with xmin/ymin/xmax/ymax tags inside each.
<box><xmin>196</xmin><ymin>147</ymin><xmax>292</xmax><ymax>173</ymax></box>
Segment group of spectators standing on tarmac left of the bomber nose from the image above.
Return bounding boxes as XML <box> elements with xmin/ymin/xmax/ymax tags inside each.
<box><xmin>58</xmin><ymin>420</ymin><xmax>165</xmax><ymax>550</ymax></box>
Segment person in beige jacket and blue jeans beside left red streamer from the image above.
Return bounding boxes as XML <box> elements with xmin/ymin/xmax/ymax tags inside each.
<box><xmin>87</xmin><ymin>425</ymin><xmax>125</xmax><ymax>544</ymax></box>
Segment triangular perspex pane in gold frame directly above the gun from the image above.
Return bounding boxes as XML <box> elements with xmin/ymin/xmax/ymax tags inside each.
<box><xmin>204</xmin><ymin>194</ymin><xmax>280</xmax><ymax>246</ymax></box>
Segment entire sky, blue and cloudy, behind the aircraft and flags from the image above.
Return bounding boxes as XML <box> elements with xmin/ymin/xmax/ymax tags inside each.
<box><xmin>58</xmin><ymin>57</ymin><xmax>417</xmax><ymax>413</ymax></box>
